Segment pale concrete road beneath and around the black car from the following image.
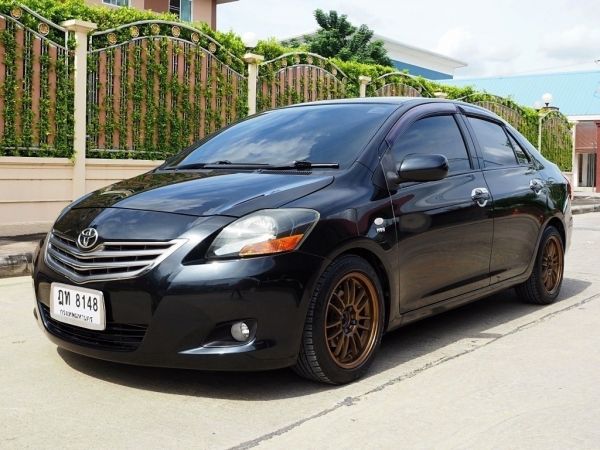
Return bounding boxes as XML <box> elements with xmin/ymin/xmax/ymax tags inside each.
<box><xmin>0</xmin><ymin>213</ymin><xmax>600</xmax><ymax>449</ymax></box>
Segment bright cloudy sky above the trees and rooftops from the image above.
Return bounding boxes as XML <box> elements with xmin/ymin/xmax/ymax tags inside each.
<box><xmin>217</xmin><ymin>0</ymin><xmax>600</xmax><ymax>78</ymax></box>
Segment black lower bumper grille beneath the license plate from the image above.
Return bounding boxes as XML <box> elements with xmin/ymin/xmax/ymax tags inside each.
<box><xmin>40</xmin><ymin>303</ymin><xmax>148</xmax><ymax>352</ymax></box>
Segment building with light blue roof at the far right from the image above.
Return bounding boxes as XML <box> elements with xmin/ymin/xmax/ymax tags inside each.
<box><xmin>442</xmin><ymin>70</ymin><xmax>600</xmax><ymax>192</ymax></box>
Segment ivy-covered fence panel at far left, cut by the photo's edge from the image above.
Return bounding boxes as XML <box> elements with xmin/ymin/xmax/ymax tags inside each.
<box><xmin>0</xmin><ymin>6</ymin><xmax>73</xmax><ymax>156</ymax></box>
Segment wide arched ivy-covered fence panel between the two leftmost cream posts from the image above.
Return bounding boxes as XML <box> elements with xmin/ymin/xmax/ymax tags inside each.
<box><xmin>87</xmin><ymin>21</ymin><xmax>247</xmax><ymax>159</ymax></box>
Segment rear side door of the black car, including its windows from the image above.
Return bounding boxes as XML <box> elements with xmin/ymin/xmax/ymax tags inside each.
<box><xmin>466</xmin><ymin>115</ymin><xmax>547</xmax><ymax>283</ymax></box>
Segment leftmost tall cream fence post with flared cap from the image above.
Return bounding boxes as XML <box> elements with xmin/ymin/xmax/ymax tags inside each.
<box><xmin>61</xmin><ymin>19</ymin><xmax>97</xmax><ymax>200</ymax></box>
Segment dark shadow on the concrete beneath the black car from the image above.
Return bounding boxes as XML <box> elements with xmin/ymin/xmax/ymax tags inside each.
<box><xmin>57</xmin><ymin>278</ymin><xmax>591</xmax><ymax>401</ymax></box>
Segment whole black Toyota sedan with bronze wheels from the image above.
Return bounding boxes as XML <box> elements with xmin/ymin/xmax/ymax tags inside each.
<box><xmin>33</xmin><ymin>98</ymin><xmax>572</xmax><ymax>384</ymax></box>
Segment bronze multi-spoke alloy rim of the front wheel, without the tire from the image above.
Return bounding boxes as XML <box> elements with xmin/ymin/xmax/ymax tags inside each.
<box><xmin>325</xmin><ymin>272</ymin><xmax>380</xmax><ymax>369</ymax></box>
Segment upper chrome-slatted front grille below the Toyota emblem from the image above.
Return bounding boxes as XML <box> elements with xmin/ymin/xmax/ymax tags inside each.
<box><xmin>46</xmin><ymin>231</ymin><xmax>185</xmax><ymax>283</ymax></box>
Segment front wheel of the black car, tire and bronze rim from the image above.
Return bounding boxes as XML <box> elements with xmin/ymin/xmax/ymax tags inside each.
<box><xmin>293</xmin><ymin>255</ymin><xmax>385</xmax><ymax>384</ymax></box>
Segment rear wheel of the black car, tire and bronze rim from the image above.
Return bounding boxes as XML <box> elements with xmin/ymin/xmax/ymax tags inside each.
<box><xmin>516</xmin><ymin>226</ymin><xmax>565</xmax><ymax>305</ymax></box>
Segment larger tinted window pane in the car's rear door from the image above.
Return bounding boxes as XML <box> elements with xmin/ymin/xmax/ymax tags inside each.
<box><xmin>469</xmin><ymin>117</ymin><xmax>517</xmax><ymax>169</ymax></box>
